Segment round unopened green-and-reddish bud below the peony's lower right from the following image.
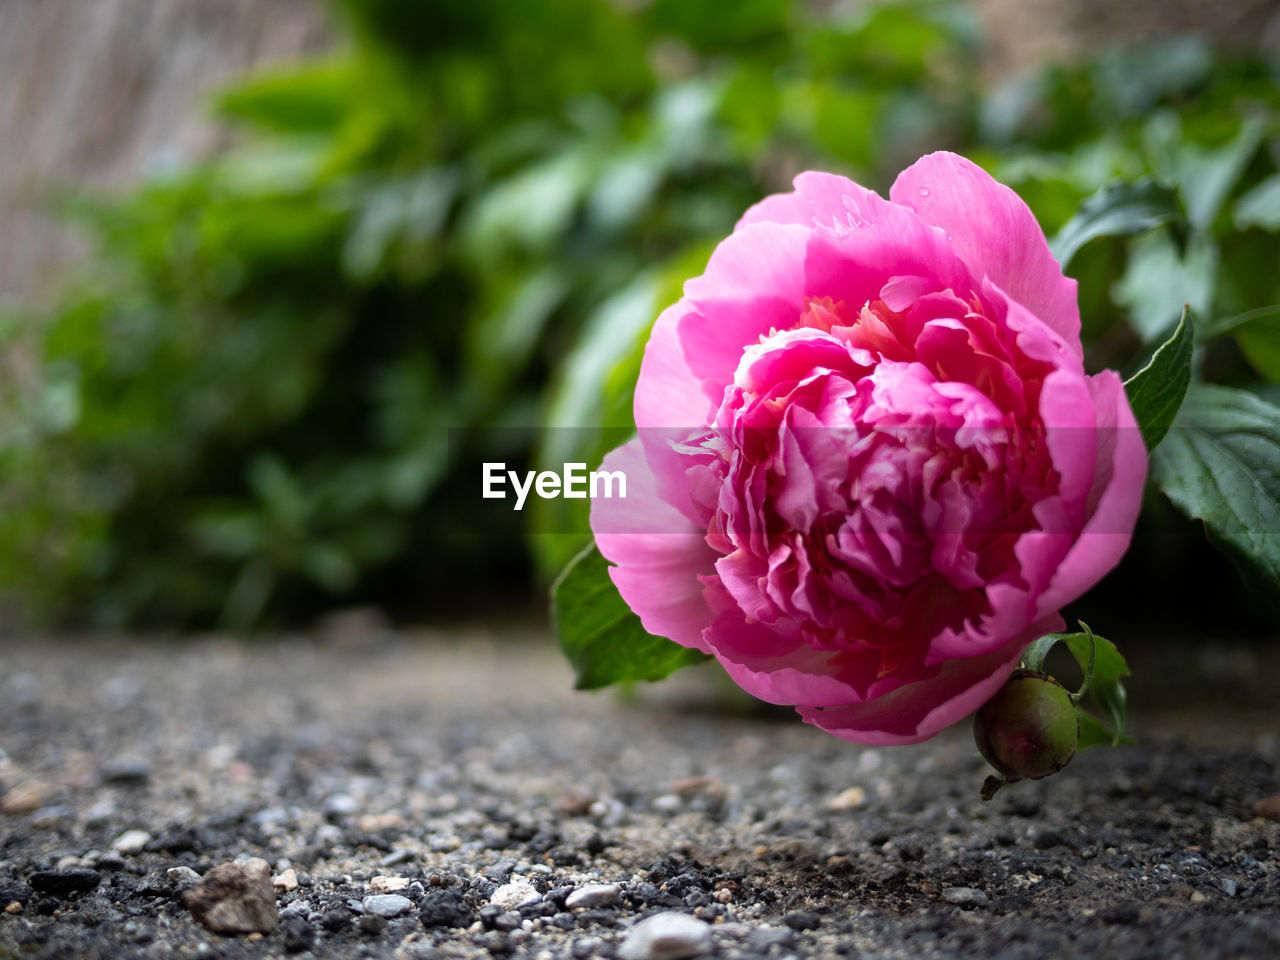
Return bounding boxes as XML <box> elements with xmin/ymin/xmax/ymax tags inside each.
<box><xmin>973</xmin><ymin>669</ymin><xmax>1080</xmax><ymax>780</ymax></box>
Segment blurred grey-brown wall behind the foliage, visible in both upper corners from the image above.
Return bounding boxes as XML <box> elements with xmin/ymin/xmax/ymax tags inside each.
<box><xmin>0</xmin><ymin>0</ymin><xmax>1280</xmax><ymax>300</ymax></box>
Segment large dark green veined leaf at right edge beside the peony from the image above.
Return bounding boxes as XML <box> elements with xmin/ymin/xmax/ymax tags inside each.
<box><xmin>1151</xmin><ymin>384</ymin><xmax>1280</xmax><ymax>602</ymax></box>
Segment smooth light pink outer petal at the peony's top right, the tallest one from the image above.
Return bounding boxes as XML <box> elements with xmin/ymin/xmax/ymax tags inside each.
<box><xmin>890</xmin><ymin>152</ymin><xmax>1083</xmax><ymax>355</ymax></box>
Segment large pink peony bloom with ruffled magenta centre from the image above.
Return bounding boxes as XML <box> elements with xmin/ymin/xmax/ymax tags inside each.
<box><xmin>591</xmin><ymin>154</ymin><xmax>1147</xmax><ymax>744</ymax></box>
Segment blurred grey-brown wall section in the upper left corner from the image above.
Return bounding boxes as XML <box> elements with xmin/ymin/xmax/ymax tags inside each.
<box><xmin>0</xmin><ymin>0</ymin><xmax>329</xmax><ymax>298</ymax></box>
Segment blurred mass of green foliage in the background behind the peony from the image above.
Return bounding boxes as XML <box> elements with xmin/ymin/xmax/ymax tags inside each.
<box><xmin>0</xmin><ymin>0</ymin><xmax>1280</xmax><ymax>627</ymax></box>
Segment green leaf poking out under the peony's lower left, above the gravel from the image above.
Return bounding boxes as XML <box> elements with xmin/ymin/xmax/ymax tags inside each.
<box><xmin>552</xmin><ymin>544</ymin><xmax>708</xmax><ymax>690</ymax></box>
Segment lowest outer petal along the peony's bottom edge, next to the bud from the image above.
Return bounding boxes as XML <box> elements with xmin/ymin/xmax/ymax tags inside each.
<box><xmin>797</xmin><ymin>614</ymin><xmax>1062</xmax><ymax>746</ymax></box>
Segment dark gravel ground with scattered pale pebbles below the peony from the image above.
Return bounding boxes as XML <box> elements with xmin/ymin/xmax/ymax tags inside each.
<box><xmin>0</xmin><ymin>628</ymin><xmax>1280</xmax><ymax>960</ymax></box>
